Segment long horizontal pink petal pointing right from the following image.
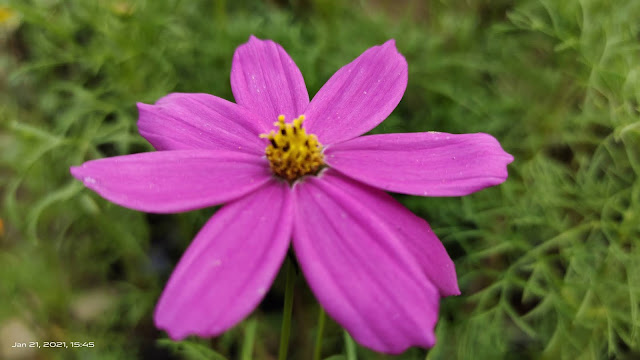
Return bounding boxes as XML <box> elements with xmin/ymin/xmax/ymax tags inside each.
<box><xmin>325</xmin><ymin>132</ymin><xmax>513</xmax><ymax>196</ymax></box>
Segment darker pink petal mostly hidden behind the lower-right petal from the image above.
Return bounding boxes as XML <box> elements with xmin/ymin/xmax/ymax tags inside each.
<box><xmin>322</xmin><ymin>169</ymin><xmax>460</xmax><ymax>296</ymax></box>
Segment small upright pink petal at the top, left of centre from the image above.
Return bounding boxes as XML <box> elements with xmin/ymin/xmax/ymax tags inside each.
<box><xmin>231</xmin><ymin>35</ymin><xmax>309</xmax><ymax>122</ymax></box>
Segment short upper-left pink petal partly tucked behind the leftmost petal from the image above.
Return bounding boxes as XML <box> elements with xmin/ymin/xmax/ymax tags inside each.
<box><xmin>138</xmin><ymin>93</ymin><xmax>271</xmax><ymax>154</ymax></box>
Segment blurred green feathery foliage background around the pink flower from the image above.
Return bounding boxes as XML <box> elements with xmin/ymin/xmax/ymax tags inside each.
<box><xmin>0</xmin><ymin>0</ymin><xmax>640</xmax><ymax>360</ymax></box>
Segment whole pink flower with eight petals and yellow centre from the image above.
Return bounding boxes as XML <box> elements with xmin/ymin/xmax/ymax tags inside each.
<box><xmin>71</xmin><ymin>36</ymin><xmax>513</xmax><ymax>353</ymax></box>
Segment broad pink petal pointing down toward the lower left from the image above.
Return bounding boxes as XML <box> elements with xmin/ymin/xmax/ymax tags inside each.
<box><xmin>154</xmin><ymin>179</ymin><xmax>292</xmax><ymax>340</ymax></box>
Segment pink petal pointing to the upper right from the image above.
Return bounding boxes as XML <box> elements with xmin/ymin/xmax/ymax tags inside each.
<box><xmin>305</xmin><ymin>40</ymin><xmax>408</xmax><ymax>145</ymax></box>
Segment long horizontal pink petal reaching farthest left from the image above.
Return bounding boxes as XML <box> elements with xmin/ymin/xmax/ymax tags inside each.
<box><xmin>71</xmin><ymin>150</ymin><xmax>271</xmax><ymax>213</ymax></box>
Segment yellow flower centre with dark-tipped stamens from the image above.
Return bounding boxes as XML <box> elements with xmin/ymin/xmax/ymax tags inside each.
<box><xmin>260</xmin><ymin>115</ymin><xmax>324</xmax><ymax>182</ymax></box>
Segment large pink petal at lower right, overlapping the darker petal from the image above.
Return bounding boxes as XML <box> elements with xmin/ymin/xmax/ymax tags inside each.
<box><xmin>293</xmin><ymin>170</ymin><xmax>440</xmax><ymax>354</ymax></box>
